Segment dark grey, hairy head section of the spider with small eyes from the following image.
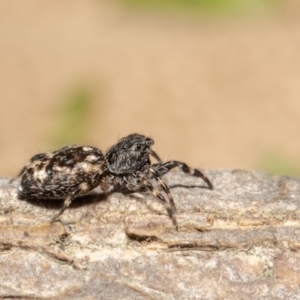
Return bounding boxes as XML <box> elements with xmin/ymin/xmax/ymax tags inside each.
<box><xmin>105</xmin><ymin>133</ymin><xmax>154</xmax><ymax>174</ymax></box>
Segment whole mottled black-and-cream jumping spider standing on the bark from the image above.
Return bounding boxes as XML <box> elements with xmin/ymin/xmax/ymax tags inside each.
<box><xmin>11</xmin><ymin>133</ymin><xmax>213</xmax><ymax>230</ymax></box>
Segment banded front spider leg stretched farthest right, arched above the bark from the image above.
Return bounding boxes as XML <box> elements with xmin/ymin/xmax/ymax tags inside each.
<box><xmin>151</xmin><ymin>160</ymin><xmax>214</xmax><ymax>190</ymax></box>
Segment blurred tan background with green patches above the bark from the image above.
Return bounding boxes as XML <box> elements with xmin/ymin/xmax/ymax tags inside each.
<box><xmin>0</xmin><ymin>0</ymin><xmax>300</xmax><ymax>176</ymax></box>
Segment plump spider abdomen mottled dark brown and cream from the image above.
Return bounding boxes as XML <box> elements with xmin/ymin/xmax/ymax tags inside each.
<box><xmin>18</xmin><ymin>145</ymin><xmax>106</xmax><ymax>199</ymax></box>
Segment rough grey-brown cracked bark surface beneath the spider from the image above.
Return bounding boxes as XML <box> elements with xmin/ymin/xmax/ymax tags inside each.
<box><xmin>0</xmin><ymin>170</ymin><xmax>300</xmax><ymax>300</ymax></box>
